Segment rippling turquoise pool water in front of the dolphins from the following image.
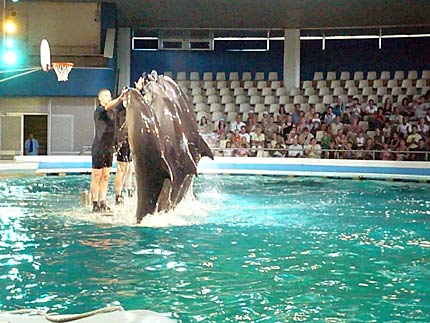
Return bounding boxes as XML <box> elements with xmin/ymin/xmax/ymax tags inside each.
<box><xmin>0</xmin><ymin>176</ymin><xmax>430</xmax><ymax>322</ymax></box>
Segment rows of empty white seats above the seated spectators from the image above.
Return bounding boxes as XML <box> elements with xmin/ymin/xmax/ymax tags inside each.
<box><xmin>164</xmin><ymin>70</ymin><xmax>430</xmax><ymax>122</ymax></box>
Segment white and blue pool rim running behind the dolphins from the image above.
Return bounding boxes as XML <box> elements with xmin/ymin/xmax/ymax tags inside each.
<box><xmin>0</xmin><ymin>156</ymin><xmax>430</xmax><ymax>182</ymax></box>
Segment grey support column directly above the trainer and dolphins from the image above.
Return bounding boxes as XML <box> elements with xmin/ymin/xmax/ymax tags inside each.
<box><xmin>117</xmin><ymin>28</ymin><xmax>131</xmax><ymax>89</ymax></box>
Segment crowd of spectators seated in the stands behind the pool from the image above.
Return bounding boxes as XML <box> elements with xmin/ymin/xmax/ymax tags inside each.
<box><xmin>199</xmin><ymin>96</ymin><xmax>430</xmax><ymax>161</ymax></box>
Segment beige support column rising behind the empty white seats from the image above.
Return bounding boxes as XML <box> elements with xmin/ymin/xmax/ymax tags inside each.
<box><xmin>284</xmin><ymin>29</ymin><xmax>300</xmax><ymax>91</ymax></box>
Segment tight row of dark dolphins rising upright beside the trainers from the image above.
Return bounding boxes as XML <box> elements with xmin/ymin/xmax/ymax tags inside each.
<box><xmin>126</xmin><ymin>72</ymin><xmax>213</xmax><ymax>223</ymax></box>
